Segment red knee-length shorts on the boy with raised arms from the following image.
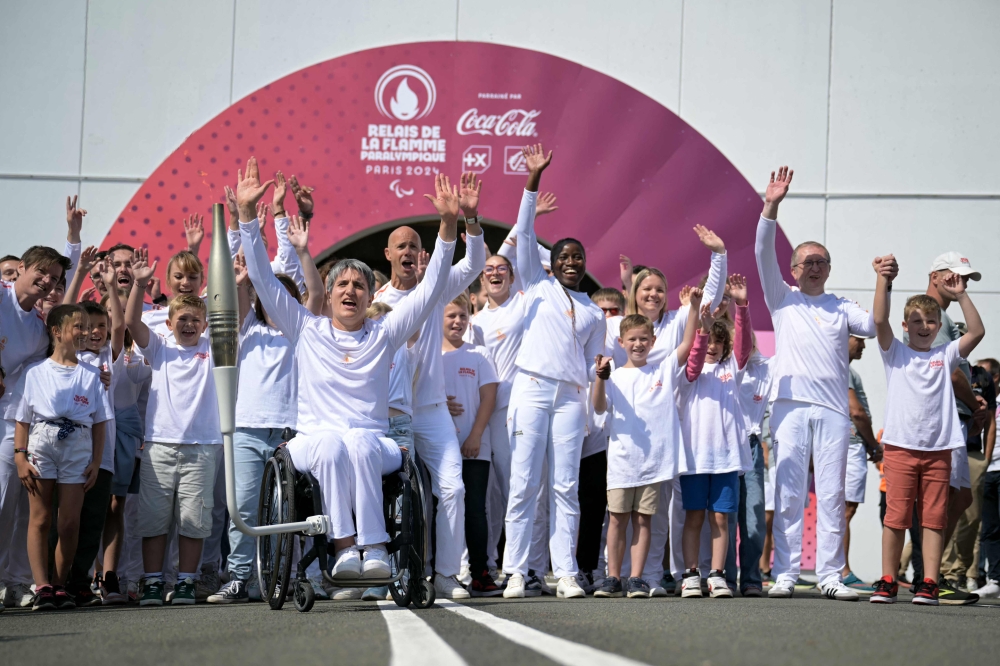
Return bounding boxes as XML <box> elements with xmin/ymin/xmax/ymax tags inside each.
<box><xmin>882</xmin><ymin>444</ymin><xmax>951</xmax><ymax>530</ymax></box>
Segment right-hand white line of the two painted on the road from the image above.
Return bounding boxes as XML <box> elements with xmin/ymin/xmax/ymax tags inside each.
<box><xmin>434</xmin><ymin>599</ymin><xmax>646</xmax><ymax>666</ymax></box>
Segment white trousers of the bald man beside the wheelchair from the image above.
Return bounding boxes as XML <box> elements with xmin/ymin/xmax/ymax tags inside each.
<box><xmin>413</xmin><ymin>403</ymin><xmax>465</xmax><ymax>576</ymax></box>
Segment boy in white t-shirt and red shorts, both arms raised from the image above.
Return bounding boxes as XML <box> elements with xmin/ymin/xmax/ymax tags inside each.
<box><xmin>871</xmin><ymin>255</ymin><xmax>986</xmax><ymax>606</ymax></box>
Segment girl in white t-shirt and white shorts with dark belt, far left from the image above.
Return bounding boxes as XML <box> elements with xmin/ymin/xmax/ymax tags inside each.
<box><xmin>12</xmin><ymin>305</ymin><xmax>112</xmax><ymax>610</ymax></box>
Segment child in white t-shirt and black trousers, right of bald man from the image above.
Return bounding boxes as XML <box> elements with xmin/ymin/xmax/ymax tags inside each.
<box><xmin>441</xmin><ymin>294</ymin><xmax>503</xmax><ymax>597</ymax></box>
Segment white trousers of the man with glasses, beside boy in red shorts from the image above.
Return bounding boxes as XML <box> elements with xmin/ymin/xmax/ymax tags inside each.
<box><xmin>771</xmin><ymin>400</ymin><xmax>851</xmax><ymax>585</ymax></box>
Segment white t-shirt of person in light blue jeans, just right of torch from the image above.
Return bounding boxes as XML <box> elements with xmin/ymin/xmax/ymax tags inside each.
<box><xmin>236</xmin><ymin>310</ymin><xmax>298</xmax><ymax>429</ymax></box>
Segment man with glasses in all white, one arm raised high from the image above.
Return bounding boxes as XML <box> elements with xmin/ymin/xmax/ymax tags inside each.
<box><xmin>755</xmin><ymin>167</ymin><xmax>898</xmax><ymax>601</ymax></box>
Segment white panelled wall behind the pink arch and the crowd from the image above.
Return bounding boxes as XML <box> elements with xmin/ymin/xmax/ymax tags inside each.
<box><xmin>0</xmin><ymin>0</ymin><xmax>1000</xmax><ymax>578</ymax></box>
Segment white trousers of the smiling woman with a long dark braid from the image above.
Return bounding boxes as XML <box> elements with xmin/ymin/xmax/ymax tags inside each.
<box><xmin>503</xmin><ymin>372</ymin><xmax>587</xmax><ymax>578</ymax></box>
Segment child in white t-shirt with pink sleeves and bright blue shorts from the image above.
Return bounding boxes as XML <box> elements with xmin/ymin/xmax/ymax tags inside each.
<box><xmin>680</xmin><ymin>275</ymin><xmax>753</xmax><ymax>597</ymax></box>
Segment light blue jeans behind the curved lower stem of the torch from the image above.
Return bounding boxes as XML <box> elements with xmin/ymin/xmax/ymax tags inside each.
<box><xmin>229</xmin><ymin>428</ymin><xmax>284</xmax><ymax>580</ymax></box>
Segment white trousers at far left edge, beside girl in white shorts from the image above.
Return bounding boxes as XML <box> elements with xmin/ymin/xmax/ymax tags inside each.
<box><xmin>0</xmin><ymin>418</ymin><xmax>33</xmax><ymax>585</ymax></box>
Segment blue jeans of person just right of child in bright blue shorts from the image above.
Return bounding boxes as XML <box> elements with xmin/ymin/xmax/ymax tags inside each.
<box><xmin>726</xmin><ymin>435</ymin><xmax>766</xmax><ymax>590</ymax></box>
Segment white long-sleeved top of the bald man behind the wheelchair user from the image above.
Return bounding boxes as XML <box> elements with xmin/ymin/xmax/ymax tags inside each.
<box><xmin>375</xmin><ymin>234</ymin><xmax>486</xmax><ymax>408</ymax></box>
